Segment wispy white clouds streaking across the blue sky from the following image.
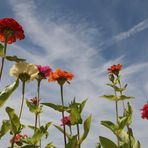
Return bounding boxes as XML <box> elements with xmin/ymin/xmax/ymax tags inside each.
<box><xmin>1</xmin><ymin>0</ymin><xmax>148</xmax><ymax>147</ymax></box>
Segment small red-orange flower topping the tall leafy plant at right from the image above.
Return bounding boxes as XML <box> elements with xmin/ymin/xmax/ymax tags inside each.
<box><xmin>107</xmin><ymin>64</ymin><xmax>122</xmax><ymax>76</ymax></box>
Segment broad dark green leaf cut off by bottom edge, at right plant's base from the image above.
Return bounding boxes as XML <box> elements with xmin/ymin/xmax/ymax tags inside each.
<box><xmin>99</xmin><ymin>136</ymin><xmax>118</xmax><ymax>148</ymax></box>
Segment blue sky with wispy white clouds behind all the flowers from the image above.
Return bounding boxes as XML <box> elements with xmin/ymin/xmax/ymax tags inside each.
<box><xmin>0</xmin><ymin>0</ymin><xmax>148</xmax><ymax>148</ymax></box>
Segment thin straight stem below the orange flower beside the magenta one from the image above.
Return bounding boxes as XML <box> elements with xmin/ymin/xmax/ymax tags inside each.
<box><xmin>60</xmin><ymin>85</ymin><xmax>66</xmax><ymax>147</ymax></box>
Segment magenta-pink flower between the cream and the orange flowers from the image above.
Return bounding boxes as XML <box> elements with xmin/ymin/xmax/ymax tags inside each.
<box><xmin>36</xmin><ymin>65</ymin><xmax>51</xmax><ymax>79</ymax></box>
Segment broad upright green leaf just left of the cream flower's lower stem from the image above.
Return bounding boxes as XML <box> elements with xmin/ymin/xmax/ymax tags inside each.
<box><xmin>6</xmin><ymin>107</ymin><xmax>21</xmax><ymax>134</ymax></box>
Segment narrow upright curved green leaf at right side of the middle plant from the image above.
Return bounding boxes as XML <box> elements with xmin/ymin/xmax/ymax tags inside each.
<box><xmin>79</xmin><ymin>115</ymin><xmax>91</xmax><ymax>144</ymax></box>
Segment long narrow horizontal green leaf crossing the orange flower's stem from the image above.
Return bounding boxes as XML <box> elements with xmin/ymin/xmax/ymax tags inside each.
<box><xmin>41</xmin><ymin>103</ymin><xmax>68</xmax><ymax>112</ymax></box>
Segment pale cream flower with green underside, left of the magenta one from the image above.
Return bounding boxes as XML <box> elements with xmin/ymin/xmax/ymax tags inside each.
<box><xmin>9</xmin><ymin>62</ymin><xmax>39</xmax><ymax>82</ymax></box>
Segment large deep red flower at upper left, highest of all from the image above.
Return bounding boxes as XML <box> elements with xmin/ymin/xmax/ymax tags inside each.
<box><xmin>0</xmin><ymin>18</ymin><xmax>25</xmax><ymax>44</ymax></box>
